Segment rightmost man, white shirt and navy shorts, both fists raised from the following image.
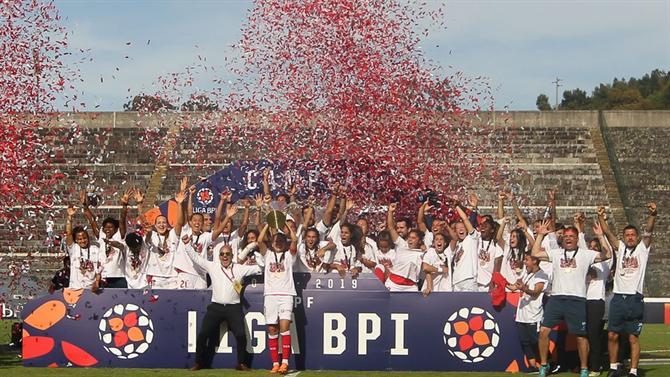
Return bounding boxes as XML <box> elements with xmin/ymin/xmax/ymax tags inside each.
<box><xmin>598</xmin><ymin>203</ymin><xmax>657</xmax><ymax>377</ymax></box>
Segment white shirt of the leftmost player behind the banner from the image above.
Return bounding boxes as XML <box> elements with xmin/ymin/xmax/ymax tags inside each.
<box><xmin>68</xmin><ymin>242</ymin><xmax>105</xmax><ymax>289</ymax></box>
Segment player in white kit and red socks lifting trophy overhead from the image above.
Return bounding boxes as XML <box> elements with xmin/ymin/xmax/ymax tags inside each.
<box><xmin>258</xmin><ymin>224</ymin><xmax>298</xmax><ymax>374</ymax></box>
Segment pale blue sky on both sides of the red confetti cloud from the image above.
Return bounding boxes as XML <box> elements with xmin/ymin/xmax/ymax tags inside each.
<box><xmin>55</xmin><ymin>0</ymin><xmax>670</xmax><ymax>111</ymax></box>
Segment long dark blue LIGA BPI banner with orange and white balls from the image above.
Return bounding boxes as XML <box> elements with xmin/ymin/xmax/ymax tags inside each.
<box><xmin>22</xmin><ymin>274</ymin><xmax>536</xmax><ymax>371</ymax></box>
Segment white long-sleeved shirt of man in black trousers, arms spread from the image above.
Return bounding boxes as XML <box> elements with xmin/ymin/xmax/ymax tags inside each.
<box><xmin>184</xmin><ymin>243</ymin><xmax>261</xmax><ymax>304</ymax></box>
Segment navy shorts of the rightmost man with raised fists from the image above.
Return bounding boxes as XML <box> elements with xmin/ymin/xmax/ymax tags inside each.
<box><xmin>607</xmin><ymin>293</ymin><xmax>644</xmax><ymax>336</ymax></box>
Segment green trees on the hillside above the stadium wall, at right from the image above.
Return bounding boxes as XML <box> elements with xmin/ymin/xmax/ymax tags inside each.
<box><xmin>536</xmin><ymin>69</ymin><xmax>670</xmax><ymax>110</ymax></box>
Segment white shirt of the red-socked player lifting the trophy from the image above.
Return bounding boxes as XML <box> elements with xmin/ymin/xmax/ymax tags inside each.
<box><xmin>263</xmin><ymin>249</ymin><xmax>298</xmax><ymax>296</ymax></box>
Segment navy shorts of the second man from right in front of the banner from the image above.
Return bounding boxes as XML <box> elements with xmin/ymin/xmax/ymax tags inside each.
<box><xmin>542</xmin><ymin>296</ymin><xmax>586</xmax><ymax>336</ymax></box>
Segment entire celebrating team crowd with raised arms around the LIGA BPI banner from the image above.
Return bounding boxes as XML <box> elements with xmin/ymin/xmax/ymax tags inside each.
<box><xmin>51</xmin><ymin>169</ymin><xmax>656</xmax><ymax>376</ymax></box>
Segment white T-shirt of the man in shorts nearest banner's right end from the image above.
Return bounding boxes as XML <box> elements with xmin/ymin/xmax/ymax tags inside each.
<box><xmin>547</xmin><ymin>249</ymin><xmax>599</xmax><ymax>299</ymax></box>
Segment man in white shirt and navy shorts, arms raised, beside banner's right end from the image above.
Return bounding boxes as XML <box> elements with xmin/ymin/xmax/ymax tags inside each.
<box><xmin>532</xmin><ymin>220</ymin><xmax>612</xmax><ymax>377</ymax></box>
